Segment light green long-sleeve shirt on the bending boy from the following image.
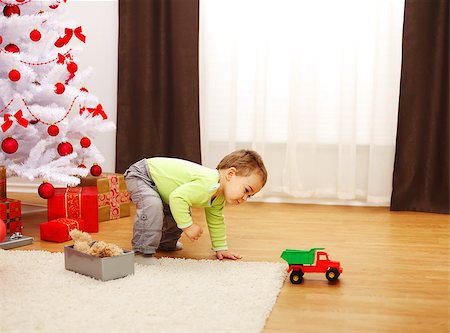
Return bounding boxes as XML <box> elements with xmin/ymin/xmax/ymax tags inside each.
<box><xmin>147</xmin><ymin>157</ymin><xmax>228</xmax><ymax>251</ymax></box>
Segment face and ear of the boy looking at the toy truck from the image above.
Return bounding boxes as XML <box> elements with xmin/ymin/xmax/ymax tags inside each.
<box><xmin>223</xmin><ymin>168</ymin><xmax>263</xmax><ymax>205</ymax></box>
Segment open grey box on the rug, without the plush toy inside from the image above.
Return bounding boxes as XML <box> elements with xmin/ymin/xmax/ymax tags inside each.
<box><xmin>64</xmin><ymin>245</ymin><xmax>134</xmax><ymax>281</ymax></box>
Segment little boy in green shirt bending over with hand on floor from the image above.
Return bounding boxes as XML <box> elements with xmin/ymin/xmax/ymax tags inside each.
<box><xmin>125</xmin><ymin>149</ymin><xmax>267</xmax><ymax>260</ymax></box>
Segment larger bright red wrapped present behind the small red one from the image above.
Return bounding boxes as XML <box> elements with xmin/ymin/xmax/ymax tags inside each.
<box><xmin>47</xmin><ymin>186</ymin><xmax>98</xmax><ymax>232</ymax></box>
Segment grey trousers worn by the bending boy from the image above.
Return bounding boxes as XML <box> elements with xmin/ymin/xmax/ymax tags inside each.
<box><xmin>124</xmin><ymin>159</ymin><xmax>182</xmax><ymax>254</ymax></box>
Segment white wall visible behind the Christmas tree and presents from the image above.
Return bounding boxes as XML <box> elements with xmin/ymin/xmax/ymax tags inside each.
<box><xmin>8</xmin><ymin>0</ymin><xmax>119</xmax><ymax>192</ymax></box>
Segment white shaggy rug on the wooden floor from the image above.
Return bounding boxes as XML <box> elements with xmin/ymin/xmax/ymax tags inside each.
<box><xmin>0</xmin><ymin>250</ymin><xmax>286</xmax><ymax>333</ymax></box>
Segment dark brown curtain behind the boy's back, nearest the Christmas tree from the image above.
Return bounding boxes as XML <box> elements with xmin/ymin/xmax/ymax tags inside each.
<box><xmin>116</xmin><ymin>0</ymin><xmax>200</xmax><ymax>172</ymax></box>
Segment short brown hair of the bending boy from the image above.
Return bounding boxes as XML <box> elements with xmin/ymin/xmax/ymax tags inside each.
<box><xmin>216</xmin><ymin>149</ymin><xmax>267</xmax><ymax>186</ymax></box>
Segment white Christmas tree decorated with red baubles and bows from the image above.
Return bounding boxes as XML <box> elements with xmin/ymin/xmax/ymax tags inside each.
<box><xmin>0</xmin><ymin>0</ymin><xmax>115</xmax><ymax>197</ymax></box>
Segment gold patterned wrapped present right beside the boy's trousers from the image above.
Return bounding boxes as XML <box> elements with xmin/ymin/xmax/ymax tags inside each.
<box><xmin>80</xmin><ymin>173</ymin><xmax>131</xmax><ymax>222</ymax></box>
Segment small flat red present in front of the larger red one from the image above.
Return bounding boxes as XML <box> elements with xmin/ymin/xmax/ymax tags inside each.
<box><xmin>39</xmin><ymin>217</ymin><xmax>85</xmax><ymax>243</ymax></box>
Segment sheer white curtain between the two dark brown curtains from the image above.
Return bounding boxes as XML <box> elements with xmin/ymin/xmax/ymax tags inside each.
<box><xmin>200</xmin><ymin>0</ymin><xmax>404</xmax><ymax>205</ymax></box>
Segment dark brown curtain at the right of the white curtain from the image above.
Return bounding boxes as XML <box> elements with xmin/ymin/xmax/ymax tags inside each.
<box><xmin>391</xmin><ymin>0</ymin><xmax>450</xmax><ymax>214</ymax></box>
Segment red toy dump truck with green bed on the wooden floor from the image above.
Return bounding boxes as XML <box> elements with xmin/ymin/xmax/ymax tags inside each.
<box><xmin>281</xmin><ymin>247</ymin><xmax>342</xmax><ymax>284</ymax></box>
